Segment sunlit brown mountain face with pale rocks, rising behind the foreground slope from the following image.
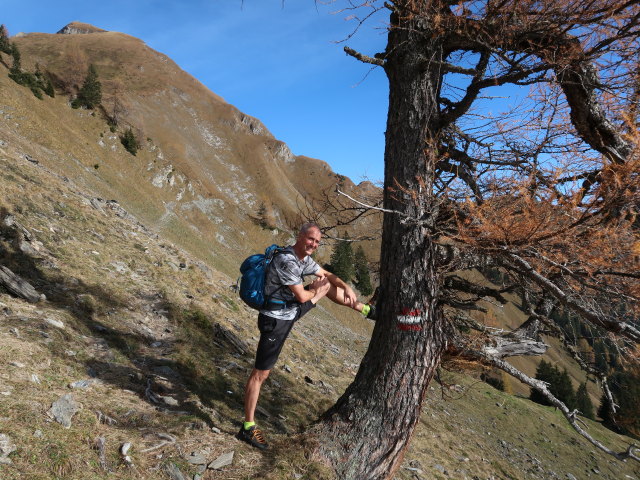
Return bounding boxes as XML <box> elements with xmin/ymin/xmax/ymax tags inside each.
<box><xmin>5</xmin><ymin>22</ymin><xmax>380</xmax><ymax>273</ymax></box>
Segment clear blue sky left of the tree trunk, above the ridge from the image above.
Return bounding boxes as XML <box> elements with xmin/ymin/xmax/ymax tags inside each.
<box><xmin>0</xmin><ymin>0</ymin><xmax>388</xmax><ymax>183</ymax></box>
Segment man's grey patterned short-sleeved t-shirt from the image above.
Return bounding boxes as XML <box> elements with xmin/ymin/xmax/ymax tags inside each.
<box><xmin>260</xmin><ymin>246</ymin><xmax>320</xmax><ymax>320</ymax></box>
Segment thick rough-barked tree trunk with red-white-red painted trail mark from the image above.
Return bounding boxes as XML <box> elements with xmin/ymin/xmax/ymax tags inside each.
<box><xmin>314</xmin><ymin>5</ymin><xmax>446</xmax><ymax>480</ymax></box>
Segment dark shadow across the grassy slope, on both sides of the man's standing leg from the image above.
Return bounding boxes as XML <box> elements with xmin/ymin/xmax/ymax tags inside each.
<box><xmin>0</xmin><ymin>208</ymin><xmax>330</xmax><ymax>466</ymax></box>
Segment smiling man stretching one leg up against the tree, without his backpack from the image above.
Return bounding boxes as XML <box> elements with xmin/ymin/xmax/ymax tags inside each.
<box><xmin>238</xmin><ymin>223</ymin><xmax>375</xmax><ymax>449</ymax></box>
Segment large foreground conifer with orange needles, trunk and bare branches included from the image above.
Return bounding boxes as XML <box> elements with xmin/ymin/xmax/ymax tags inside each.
<box><xmin>309</xmin><ymin>0</ymin><xmax>640</xmax><ymax>472</ymax></box>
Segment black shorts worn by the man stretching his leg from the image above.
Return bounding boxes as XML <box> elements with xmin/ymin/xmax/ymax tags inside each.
<box><xmin>255</xmin><ymin>301</ymin><xmax>315</xmax><ymax>370</ymax></box>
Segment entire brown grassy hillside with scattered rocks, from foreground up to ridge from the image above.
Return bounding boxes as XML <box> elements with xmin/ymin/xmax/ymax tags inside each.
<box><xmin>0</xmin><ymin>20</ymin><xmax>640</xmax><ymax>480</ymax></box>
